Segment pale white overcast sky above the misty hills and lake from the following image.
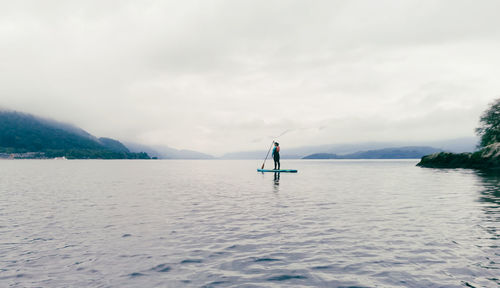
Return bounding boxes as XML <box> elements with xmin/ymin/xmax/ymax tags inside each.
<box><xmin>0</xmin><ymin>0</ymin><xmax>500</xmax><ymax>154</ymax></box>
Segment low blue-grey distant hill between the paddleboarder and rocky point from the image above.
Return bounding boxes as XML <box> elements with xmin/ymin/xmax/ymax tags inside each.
<box><xmin>302</xmin><ymin>146</ymin><xmax>443</xmax><ymax>159</ymax></box>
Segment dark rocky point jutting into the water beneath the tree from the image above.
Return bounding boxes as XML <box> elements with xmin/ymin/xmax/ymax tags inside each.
<box><xmin>417</xmin><ymin>142</ymin><xmax>500</xmax><ymax>170</ymax></box>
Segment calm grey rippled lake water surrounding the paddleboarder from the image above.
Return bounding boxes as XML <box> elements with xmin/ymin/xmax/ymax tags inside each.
<box><xmin>0</xmin><ymin>160</ymin><xmax>500</xmax><ymax>287</ymax></box>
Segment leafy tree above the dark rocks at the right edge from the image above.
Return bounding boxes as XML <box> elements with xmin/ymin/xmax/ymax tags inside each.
<box><xmin>476</xmin><ymin>98</ymin><xmax>500</xmax><ymax>147</ymax></box>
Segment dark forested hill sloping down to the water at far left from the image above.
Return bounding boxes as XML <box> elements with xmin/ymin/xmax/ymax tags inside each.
<box><xmin>0</xmin><ymin>111</ymin><xmax>149</xmax><ymax>159</ymax></box>
